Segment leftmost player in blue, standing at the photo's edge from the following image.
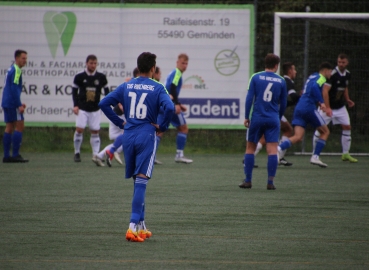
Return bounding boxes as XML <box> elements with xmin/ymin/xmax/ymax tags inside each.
<box><xmin>1</xmin><ymin>50</ymin><xmax>28</xmax><ymax>163</ymax></box>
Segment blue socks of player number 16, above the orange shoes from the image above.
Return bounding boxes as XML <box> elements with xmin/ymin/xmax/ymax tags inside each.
<box><xmin>130</xmin><ymin>177</ymin><xmax>149</xmax><ymax>224</ymax></box>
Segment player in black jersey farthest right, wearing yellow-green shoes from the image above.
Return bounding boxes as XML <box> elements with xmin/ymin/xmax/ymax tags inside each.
<box><xmin>313</xmin><ymin>53</ymin><xmax>357</xmax><ymax>163</ymax></box>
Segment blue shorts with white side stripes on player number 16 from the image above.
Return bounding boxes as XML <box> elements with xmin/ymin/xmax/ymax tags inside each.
<box><xmin>122</xmin><ymin>129</ymin><xmax>156</xmax><ymax>178</ymax></box>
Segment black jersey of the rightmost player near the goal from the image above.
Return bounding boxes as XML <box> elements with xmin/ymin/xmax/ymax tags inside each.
<box><xmin>326</xmin><ymin>67</ymin><xmax>351</xmax><ymax>109</ymax></box>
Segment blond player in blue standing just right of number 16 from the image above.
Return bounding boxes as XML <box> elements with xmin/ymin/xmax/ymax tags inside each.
<box><xmin>157</xmin><ymin>53</ymin><xmax>193</xmax><ymax>164</ymax></box>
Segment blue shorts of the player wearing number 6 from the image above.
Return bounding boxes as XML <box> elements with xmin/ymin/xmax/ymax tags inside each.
<box><xmin>246</xmin><ymin>118</ymin><xmax>281</xmax><ymax>144</ymax></box>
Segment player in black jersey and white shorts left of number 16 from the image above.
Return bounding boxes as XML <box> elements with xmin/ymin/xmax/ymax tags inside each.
<box><xmin>73</xmin><ymin>54</ymin><xmax>109</xmax><ymax>162</ymax></box>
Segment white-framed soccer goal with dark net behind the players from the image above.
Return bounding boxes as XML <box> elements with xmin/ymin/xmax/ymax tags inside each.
<box><xmin>274</xmin><ymin>12</ymin><xmax>369</xmax><ymax>155</ymax></box>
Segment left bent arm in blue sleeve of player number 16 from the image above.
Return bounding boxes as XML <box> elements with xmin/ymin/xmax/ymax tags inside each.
<box><xmin>99</xmin><ymin>87</ymin><xmax>124</xmax><ymax>129</ymax></box>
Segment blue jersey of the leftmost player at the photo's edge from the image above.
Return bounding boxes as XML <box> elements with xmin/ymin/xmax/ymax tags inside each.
<box><xmin>1</xmin><ymin>64</ymin><xmax>22</xmax><ymax>108</ymax></box>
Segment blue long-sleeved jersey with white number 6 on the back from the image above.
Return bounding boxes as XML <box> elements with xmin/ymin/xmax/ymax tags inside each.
<box><xmin>245</xmin><ymin>71</ymin><xmax>287</xmax><ymax>120</ymax></box>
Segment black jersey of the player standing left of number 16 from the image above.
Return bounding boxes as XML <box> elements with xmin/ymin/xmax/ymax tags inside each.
<box><xmin>73</xmin><ymin>71</ymin><xmax>109</xmax><ymax>112</ymax></box>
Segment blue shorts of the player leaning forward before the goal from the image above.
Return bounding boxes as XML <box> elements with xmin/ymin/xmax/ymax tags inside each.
<box><xmin>292</xmin><ymin>107</ymin><xmax>325</xmax><ymax>128</ymax></box>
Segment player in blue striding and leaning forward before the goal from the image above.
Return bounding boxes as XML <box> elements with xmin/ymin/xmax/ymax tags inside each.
<box><xmin>278</xmin><ymin>62</ymin><xmax>332</xmax><ymax>168</ymax></box>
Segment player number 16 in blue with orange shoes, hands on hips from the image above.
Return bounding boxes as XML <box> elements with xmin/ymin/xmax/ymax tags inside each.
<box><xmin>99</xmin><ymin>52</ymin><xmax>174</xmax><ymax>242</ymax></box>
